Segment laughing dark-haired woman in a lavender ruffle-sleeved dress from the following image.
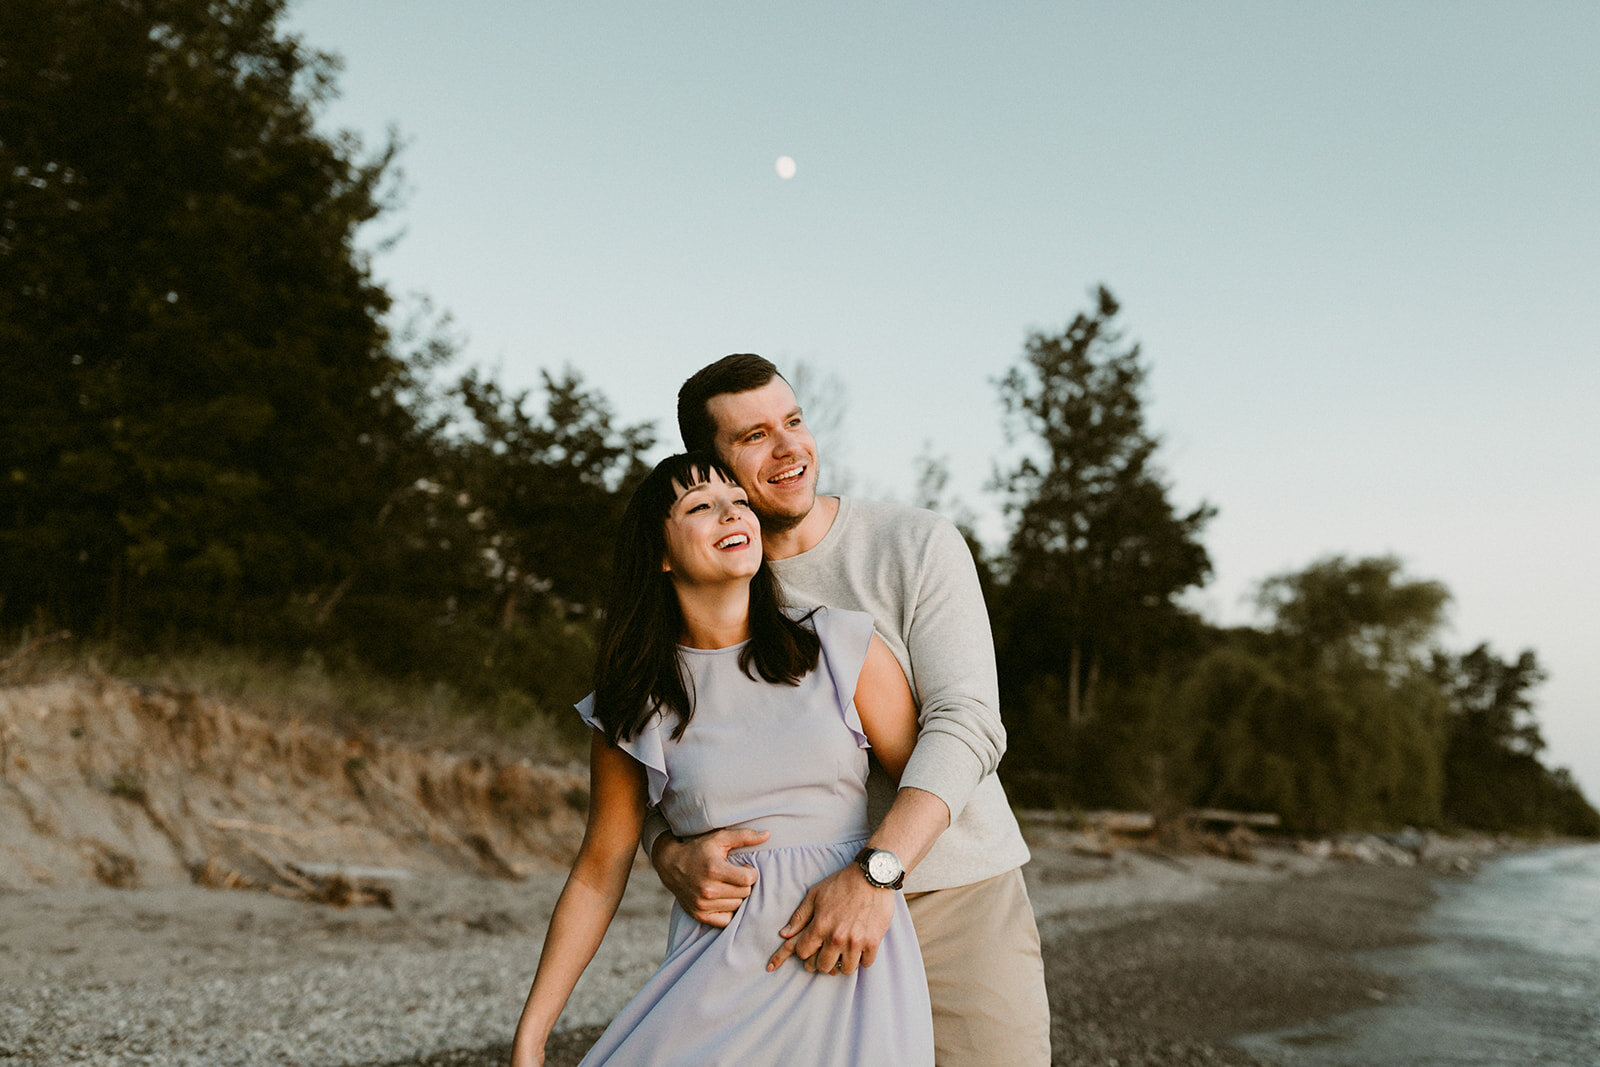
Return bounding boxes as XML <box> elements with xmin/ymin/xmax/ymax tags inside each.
<box><xmin>512</xmin><ymin>456</ymin><xmax>933</xmax><ymax>1067</ymax></box>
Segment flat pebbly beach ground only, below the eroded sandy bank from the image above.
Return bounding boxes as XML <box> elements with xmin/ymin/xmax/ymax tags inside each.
<box><xmin>0</xmin><ymin>825</ymin><xmax>1465</xmax><ymax>1067</ymax></box>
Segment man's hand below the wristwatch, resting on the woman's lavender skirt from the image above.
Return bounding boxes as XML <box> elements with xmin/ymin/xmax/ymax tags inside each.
<box><xmin>766</xmin><ymin>864</ymin><xmax>894</xmax><ymax>974</ymax></box>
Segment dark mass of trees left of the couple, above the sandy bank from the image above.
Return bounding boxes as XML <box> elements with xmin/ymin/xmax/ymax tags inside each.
<box><xmin>0</xmin><ymin>0</ymin><xmax>653</xmax><ymax>715</ymax></box>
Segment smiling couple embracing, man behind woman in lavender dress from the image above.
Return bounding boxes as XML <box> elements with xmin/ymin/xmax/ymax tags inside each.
<box><xmin>512</xmin><ymin>355</ymin><xmax>1050</xmax><ymax>1067</ymax></box>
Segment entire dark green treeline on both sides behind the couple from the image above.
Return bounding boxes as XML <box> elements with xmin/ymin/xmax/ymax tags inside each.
<box><xmin>0</xmin><ymin>0</ymin><xmax>1600</xmax><ymax>835</ymax></box>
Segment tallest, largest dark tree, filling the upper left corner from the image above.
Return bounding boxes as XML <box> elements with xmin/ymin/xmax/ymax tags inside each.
<box><xmin>0</xmin><ymin>0</ymin><xmax>427</xmax><ymax>635</ymax></box>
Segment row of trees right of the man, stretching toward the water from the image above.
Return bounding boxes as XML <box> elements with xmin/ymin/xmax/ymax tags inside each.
<box><xmin>953</xmin><ymin>288</ymin><xmax>1600</xmax><ymax>837</ymax></box>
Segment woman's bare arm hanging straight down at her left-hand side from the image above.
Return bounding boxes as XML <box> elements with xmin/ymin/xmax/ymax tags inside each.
<box><xmin>510</xmin><ymin>729</ymin><xmax>646</xmax><ymax>1067</ymax></box>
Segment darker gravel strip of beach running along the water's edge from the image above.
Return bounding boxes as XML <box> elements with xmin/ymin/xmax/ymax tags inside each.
<box><xmin>362</xmin><ymin>864</ymin><xmax>1446</xmax><ymax>1067</ymax></box>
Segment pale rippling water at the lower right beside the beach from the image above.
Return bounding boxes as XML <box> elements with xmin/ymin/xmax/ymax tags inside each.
<box><xmin>1240</xmin><ymin>845</ymin><xmax>1600</xmax><ymax>1067</ymax></box>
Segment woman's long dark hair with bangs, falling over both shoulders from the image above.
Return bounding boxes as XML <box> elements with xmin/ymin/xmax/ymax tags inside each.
<box><xmin>594</xmin><ymin>453</ymin><xmax>821</xmax><ymax>744</ymax></box>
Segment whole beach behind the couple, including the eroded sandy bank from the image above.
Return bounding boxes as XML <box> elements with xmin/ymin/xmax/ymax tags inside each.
<box><xmin>0</xmin><ymin>675</ymin><xmax>1510</xmax><ymax>1067</ymax></box>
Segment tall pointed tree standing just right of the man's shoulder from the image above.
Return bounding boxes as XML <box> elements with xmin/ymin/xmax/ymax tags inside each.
<box><xmin>995</xmin><ymin>286</ymin><xmax>1214</xmax><ymax>731</ymax></box>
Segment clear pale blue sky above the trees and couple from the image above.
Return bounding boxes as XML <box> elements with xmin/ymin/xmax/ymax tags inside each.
<box><xmin>286</xmin><ymin>0</ymin><xmax>1600</xmax><ymax>803</ymax></box>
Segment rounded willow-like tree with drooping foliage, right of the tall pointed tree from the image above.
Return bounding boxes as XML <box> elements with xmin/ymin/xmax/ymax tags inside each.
<box><xmin>1178</xmin><ymin>557</ymin><xmax>1448</xmax><ymax>830</ymax></box>
